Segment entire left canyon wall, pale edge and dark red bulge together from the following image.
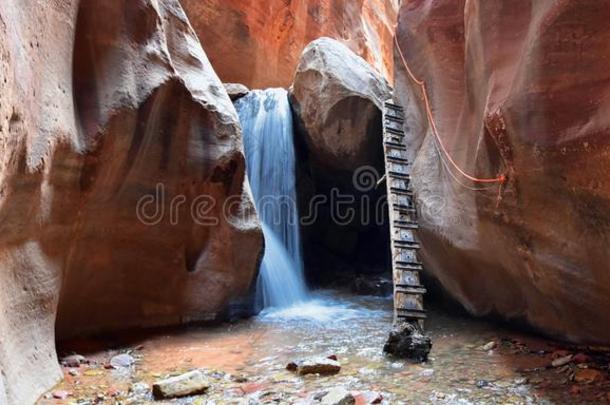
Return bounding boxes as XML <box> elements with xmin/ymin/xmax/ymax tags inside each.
<box><xmin>0</xmin><ymin>0</ymin><xmax>262</xmax><ymax>404</ymax></box>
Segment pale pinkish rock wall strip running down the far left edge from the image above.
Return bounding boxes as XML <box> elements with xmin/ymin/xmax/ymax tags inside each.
<box><xmin>0</xmin><ymin>0</ymin><xmax>78</xmax><ymax>405</ymax></box>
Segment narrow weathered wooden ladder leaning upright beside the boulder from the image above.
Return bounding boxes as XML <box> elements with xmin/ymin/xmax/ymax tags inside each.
<box><xmin>383</xmin><ymin>100</ymin><xmax>426</xmax><ymax>330</ymax></box>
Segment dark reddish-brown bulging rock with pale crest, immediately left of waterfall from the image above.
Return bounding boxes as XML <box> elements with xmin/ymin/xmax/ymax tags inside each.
<box><xmin>57</xmin><ymin>0</ymin><xmax>262</xmax><ymax>336</ymax></box>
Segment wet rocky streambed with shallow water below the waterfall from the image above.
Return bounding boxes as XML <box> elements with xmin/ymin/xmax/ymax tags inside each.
<box><xmin>39</xmin><ymin>291</ymin><xmax>610</xmax><ymax>405</ymax></box>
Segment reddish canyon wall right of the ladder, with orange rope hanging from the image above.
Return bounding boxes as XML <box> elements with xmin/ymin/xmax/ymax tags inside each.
<box><xmin>395</xmin><ymin>0</ymin><xmax>610</xmax><ymax>343</ymax></box>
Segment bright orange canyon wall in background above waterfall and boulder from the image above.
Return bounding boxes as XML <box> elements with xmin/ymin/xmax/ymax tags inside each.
<box><xmin>182</xmin><ymin>0</ymin><xmax>399</xmax><ymax>88</ymax></box>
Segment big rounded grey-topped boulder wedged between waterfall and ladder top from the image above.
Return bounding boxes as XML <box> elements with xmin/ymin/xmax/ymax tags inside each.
<box><xmin>290</xmin><ymin>38</ymin><xmax>390</xmax><ymax>172</ymax></box>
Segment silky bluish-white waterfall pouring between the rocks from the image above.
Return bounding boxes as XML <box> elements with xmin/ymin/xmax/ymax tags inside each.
<box><xmin>235</xmin><ymin>89</ymin><xmax>307</xmax><ymax>308</ymax></box>
